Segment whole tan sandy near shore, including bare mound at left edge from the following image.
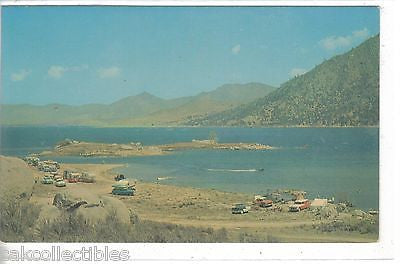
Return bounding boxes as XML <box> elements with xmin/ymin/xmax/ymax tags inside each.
<box><xmin>0</xmin><ymin>153</ymin><xmax>379</xmax><ymax>243</ymax></box>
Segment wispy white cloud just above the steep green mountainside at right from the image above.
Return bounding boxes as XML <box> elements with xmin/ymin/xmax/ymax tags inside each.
<box><xmin>319</xmin><ymin>28</ymin><xmax>370</xmax><ymax>50</ymax></box>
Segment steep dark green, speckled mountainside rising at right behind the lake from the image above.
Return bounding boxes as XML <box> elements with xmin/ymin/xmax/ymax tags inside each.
<box><xmin>191</xmin><ymin>35</ymin><xmax>379</xmax><ymax>126</ymax></box>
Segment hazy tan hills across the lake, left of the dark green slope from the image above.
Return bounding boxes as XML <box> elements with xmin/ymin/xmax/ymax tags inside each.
<box><xmin>0</xmin><ymin>83</ymin><xmax>275</xmax><ymax>126</ymax></box>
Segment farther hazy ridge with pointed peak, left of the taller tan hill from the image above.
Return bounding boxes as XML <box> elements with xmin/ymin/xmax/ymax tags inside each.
<box><xmin>0</xmin><ymin>93</ymin><xmax>168</xmax><ymax>126</ymax></box>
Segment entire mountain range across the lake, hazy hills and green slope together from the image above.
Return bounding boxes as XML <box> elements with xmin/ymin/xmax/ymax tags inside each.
<box><xmin>0</xmin><ymin>35</ymin><xmax>379</xmax><ymax>126</ymax></box>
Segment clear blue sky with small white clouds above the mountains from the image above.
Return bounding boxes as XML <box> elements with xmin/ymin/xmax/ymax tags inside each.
<box><xmin>0</xmin><ymin>6</ymin><xmax>379</xmax><ymax>105</ymax></box>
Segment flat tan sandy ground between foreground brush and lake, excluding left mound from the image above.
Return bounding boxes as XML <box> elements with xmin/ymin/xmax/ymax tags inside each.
<box><xmin>25</xmin><ymin>164</ymin><xmax>378</xmax><ymax>242</ymax></box>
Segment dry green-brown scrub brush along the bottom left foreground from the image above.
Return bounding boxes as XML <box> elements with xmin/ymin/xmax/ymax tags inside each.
<box><xmin>0</xmin><ymin>195</ymin><xmax>228</xmax><ymax>243</ymax></box>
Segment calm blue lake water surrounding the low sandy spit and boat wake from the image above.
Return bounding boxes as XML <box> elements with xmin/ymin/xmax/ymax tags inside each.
<box><xmin>0</xmin><ymin>127</ymin><xmax>379</xmax><ymax>209</ymax></box>
